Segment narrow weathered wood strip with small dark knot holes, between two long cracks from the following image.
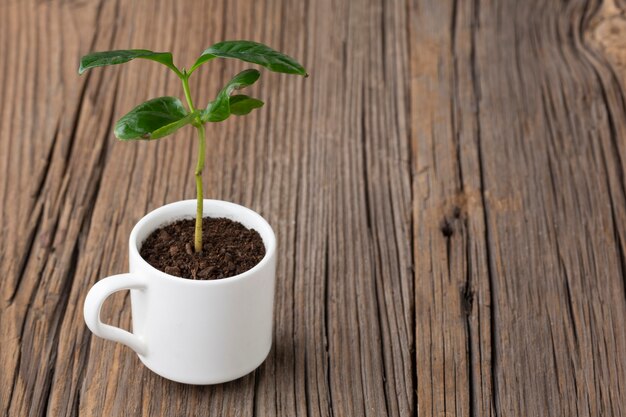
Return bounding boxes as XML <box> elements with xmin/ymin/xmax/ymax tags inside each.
<box><xmin>411</xmin><ymin>1</ymin><xmax>494</xmax><ymax>416</ymax></box>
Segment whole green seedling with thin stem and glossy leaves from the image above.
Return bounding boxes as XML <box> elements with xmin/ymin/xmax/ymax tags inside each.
<box><xmin>78</xmin><ymin>41</ymin><xmax>308</xmax><ymax>253</ymax></box>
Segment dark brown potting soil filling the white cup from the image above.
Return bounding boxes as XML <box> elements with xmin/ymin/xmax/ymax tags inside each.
<box><xmin>140</xmin><ymin>217</ymin><xmax>265</xmax><ymax>280</ymax></box>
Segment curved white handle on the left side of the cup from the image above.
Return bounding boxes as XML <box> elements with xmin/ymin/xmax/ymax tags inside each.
<box><xmin>83</xmin><ymin>274</ymin><xmax>148</xmax><ymax>355</ymax></box>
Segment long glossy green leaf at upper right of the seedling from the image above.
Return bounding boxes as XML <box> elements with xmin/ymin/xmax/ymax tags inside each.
<box><xmin>189</xmin><ymin>41</ymin><xmax>308</xmax><ymax>77</ymax></box>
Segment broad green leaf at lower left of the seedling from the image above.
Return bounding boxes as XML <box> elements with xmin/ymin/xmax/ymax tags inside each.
<box><xmin>115</xmin><ymin>97</ymin><xmax>189</xmax><ymax>140</ymax></box>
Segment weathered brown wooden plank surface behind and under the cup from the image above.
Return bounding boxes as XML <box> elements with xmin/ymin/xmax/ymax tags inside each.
<box><xmin>0</xmin><ymin>0</ymin><xmax>626</xmax><ymax>417</ymax></box>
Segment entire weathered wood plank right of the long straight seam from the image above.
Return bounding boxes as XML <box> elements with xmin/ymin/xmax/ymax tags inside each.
<box><xmin>411</xmin><ymin>1</ymin><xmax>626</xmax><ymax>415</ymax></box>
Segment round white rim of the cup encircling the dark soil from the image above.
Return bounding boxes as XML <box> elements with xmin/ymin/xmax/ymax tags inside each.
<box><xmin>128</xmin><ymin>199</ymin><xmax>276</xmax><ymax>286</ymax></box>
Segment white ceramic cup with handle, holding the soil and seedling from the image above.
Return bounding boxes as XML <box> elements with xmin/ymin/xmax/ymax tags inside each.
<box><xmin>84</xmin><ymin>200</ymin><xmax>276</xmax><ymax>385</ymax></box>
